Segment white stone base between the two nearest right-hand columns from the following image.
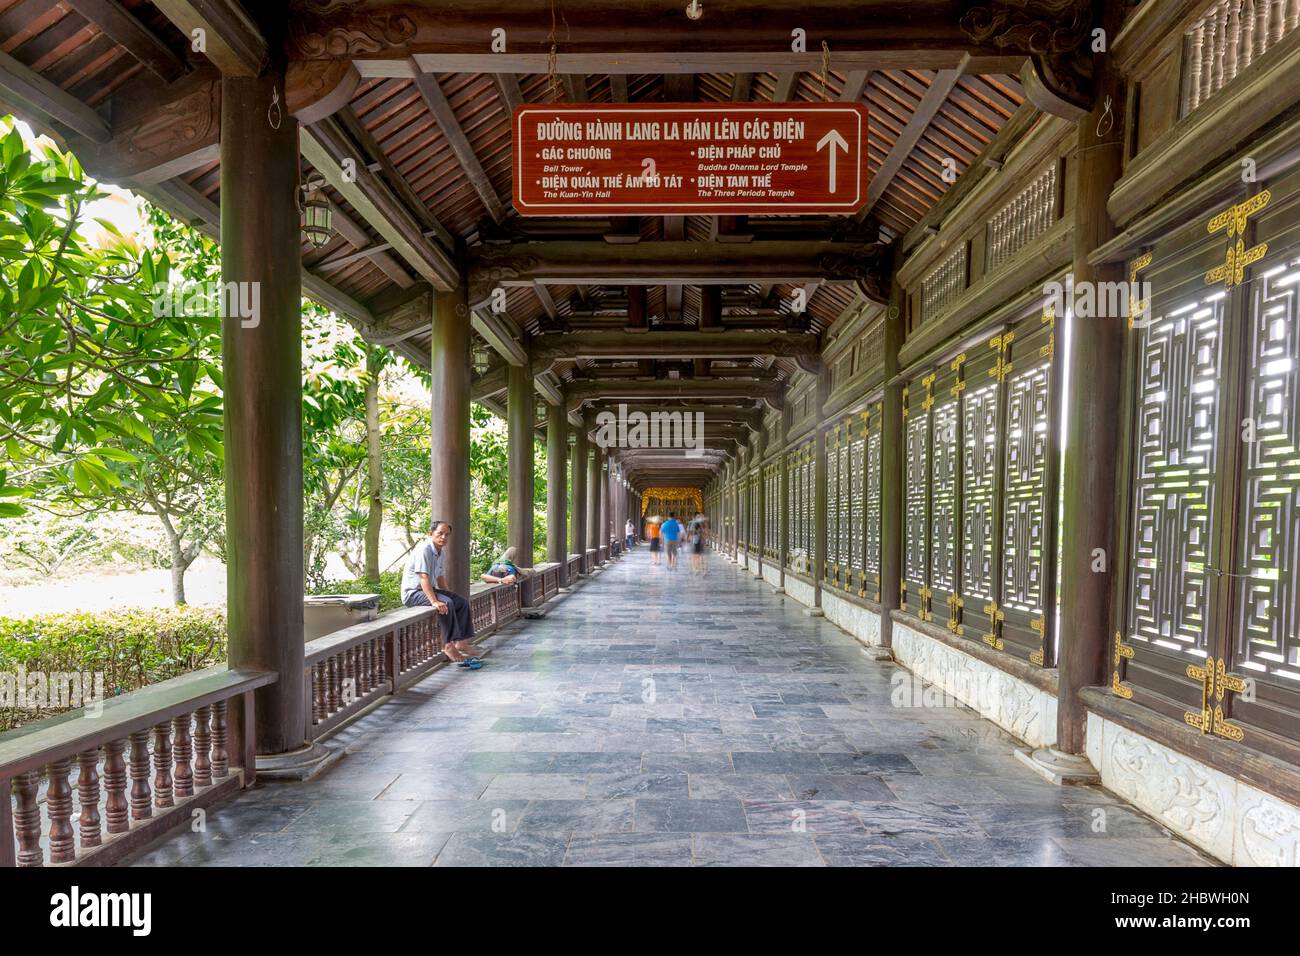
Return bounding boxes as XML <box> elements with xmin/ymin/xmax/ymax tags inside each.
<box><xmin>893</xmin><ymin>619</ymin><xmax>1057</xmax><ymax>747</ymax></box>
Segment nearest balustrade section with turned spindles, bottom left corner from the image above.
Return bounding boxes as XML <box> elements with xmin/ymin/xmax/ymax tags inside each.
<box><xmin>0</xmin><ymin>665</ymin><xmax>276</xmax><ymax>866</ymax></box>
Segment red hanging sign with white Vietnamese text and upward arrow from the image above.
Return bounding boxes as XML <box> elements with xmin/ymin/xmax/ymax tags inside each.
<box><xmin>512</xmin><ymin>103</ymin><xmax>867</xmax><ymax>216</ymax></box>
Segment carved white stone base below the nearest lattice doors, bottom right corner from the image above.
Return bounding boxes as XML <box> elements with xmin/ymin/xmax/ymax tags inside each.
<box><xmin>1087</xmin><ymin>713</ymin><xmax>1300</xmax><ymax>866</ymax></box>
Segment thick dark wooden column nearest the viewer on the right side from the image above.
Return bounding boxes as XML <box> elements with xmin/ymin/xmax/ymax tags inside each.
<box><xmin>1056</xmin><ymin>0</ymin><xmax>1127</xmax><ymax>754</ymax></box>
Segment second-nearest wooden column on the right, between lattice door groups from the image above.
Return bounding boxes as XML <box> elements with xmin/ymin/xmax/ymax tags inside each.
<box><xmin>880</xmin><ymin>250</ymin><xmax>907</xmax><ymax>648</ymax></box>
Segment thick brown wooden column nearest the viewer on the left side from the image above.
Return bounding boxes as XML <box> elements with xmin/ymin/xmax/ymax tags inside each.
<box><xmin>223</xmin><ymin>70</ymin><xmax>307</xmax><ymax>754</ymax></box>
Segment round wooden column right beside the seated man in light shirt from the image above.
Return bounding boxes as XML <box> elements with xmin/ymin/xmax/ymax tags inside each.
<box><xmin>429</xmin><ymin>285</ymin><xmax>469</xmax><ymax>594</ymax></box>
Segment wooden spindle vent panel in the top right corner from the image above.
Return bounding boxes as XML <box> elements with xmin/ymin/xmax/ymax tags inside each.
<box><xmin>1182</xmin><ymin>0</ymin><xmax>1300</xmax><ymax>116</ymax></box>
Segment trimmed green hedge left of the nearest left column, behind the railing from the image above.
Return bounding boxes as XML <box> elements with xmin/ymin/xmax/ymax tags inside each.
<box><xmin>0</xmin><ymin>606</ymin><xmax>226</xmax><ymax>730</ymax></box>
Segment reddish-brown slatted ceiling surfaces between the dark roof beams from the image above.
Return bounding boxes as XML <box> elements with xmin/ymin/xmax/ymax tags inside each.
<box><xmin>0</xmin><ymin>0</ymin><xmax>1026</xmax><ymax>486</ymax></box>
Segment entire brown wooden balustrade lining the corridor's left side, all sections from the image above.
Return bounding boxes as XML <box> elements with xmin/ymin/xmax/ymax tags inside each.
<box><xmin>0</xmin><ymin>567</ymin><xmax>597</xmax><ymax>866</ymax></box>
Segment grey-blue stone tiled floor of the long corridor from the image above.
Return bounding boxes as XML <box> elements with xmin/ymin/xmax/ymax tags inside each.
<box><xmin>126</xmin><ymin>550</ymin><xmax>1208</xmax><ymax>866</ymax></box>
